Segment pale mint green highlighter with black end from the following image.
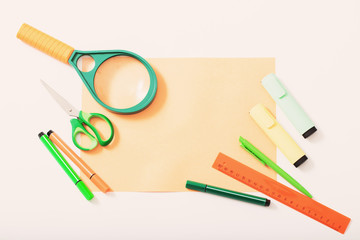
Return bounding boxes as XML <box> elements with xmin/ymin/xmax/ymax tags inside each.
<box><xmin>261</xmin><ymin>73</ymin><xmax>317</xmax><ymax>138</ymax></box>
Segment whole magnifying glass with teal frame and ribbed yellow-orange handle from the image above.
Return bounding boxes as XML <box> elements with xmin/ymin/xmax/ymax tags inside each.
<box><xmin>17</xmin><ymin>23</ymin><xmax>157</xmax><ymax>114</ymax></box>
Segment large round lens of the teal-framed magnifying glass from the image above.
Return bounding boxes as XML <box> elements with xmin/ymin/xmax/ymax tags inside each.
<box><xmin>94</xmin><ymin>56</ymin><xmax>150</xmax><ymax>109</ymax></box>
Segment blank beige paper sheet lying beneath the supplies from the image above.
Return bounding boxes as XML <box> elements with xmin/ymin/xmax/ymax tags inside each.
<box><xmin>81</xmin><ymin>58</ymin><xmax>276</xmax><ymax>191</ymax></box>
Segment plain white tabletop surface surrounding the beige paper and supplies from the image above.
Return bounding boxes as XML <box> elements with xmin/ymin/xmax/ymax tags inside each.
<box><xmin>0</xmin><ymin>0</ymin><xmax>360</xmax><ymax>240</ymax></box>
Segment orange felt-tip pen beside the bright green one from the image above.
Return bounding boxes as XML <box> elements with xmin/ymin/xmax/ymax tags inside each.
<box><xmin>47</xmin><ymin>130</ymin><xmax>110</xmax><ymax>193</ymax></box>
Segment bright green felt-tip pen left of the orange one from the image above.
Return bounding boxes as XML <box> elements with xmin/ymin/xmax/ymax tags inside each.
<box><xmin>39</xmin><ymin>132</ymin><xmax>94</xmax><ymax>200</ymax></box>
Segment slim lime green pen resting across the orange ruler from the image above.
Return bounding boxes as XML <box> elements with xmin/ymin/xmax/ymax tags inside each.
<box><xmin>239</xmin><ymin>137</ymin><xmax>312</xmax><ymax>198</ymax></box>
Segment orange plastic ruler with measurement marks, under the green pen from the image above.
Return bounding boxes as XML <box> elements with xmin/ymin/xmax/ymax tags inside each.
<box><xmin>213</xmin><ymin>153</ymin><xmax>351</xmax><ymax>234</ymax></box>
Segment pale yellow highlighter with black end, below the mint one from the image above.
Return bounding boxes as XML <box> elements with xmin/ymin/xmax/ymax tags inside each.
<box><xmin>250</xmin><ymin>104</ymin><xmax>307</xmax><ymax>167</ymax></box>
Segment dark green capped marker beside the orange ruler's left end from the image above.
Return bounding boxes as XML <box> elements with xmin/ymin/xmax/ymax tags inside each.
<box><xmin>186</xmin><ymin>180</ymin><xmax>270</xmax><ymax>207</ymax></box>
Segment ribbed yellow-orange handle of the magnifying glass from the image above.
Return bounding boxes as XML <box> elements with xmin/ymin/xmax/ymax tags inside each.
<box><xmin>16</xmin><ymin>23</ymin><xmax>74</xmax><ymax>64</ymax></box>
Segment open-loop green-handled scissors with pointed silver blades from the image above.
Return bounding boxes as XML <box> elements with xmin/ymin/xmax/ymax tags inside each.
<box><xmin>40</xmin><ymin>80</ymin><xmax>114</xmax><ymax>151</ymax></box>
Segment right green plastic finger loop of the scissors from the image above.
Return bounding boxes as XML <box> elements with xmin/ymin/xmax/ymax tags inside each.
<box><xmin>79</xmin><ymin>111</ymin><xmax>114</xmax><ymax>146</ymax></box>
